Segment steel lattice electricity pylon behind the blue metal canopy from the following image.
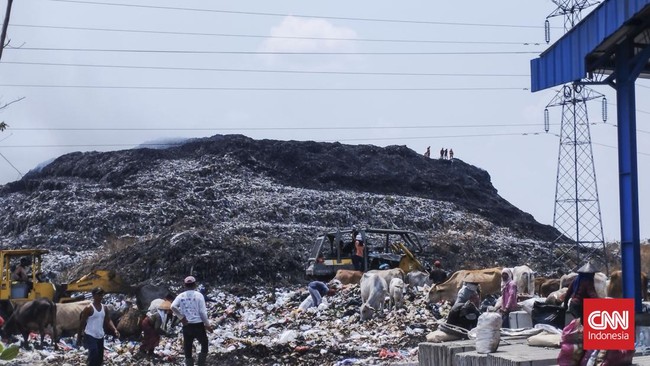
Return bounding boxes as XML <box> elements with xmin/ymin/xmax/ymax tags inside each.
<box><xmin>544</xmin><ymin>0</ymin><xmax>609</xmax><ymax>273</ymax></box>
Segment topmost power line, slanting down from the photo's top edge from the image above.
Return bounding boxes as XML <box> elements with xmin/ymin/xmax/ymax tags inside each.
<box><xmin>50</xmin><ymin>0</ymin><xmax>542</xmax><ymax>29</ymax></box>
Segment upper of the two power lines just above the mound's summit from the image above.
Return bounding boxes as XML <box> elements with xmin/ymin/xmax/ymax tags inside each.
<box><xmin>11</xmin><ymin>123</ymin><xmax>538</xmax><ymax>131</ymax></box>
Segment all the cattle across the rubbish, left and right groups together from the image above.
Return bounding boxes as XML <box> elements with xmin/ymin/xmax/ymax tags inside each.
<box><xmin>0</xmin><ymin>266</ymin><xmax>648</xmax><ymax>347</ymax></box>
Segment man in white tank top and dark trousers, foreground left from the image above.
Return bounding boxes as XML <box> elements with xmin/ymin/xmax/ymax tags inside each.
<box><xmin>77</xmin><ymin>287</ymin><xmax>120</xmax><ymax>366</ymax></box>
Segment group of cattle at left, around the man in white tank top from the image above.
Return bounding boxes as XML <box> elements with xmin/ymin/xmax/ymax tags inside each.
<box><xmin>0</xmin><ymin>285</ymin><xmax>174</xmax><ymax>348</ymax></box>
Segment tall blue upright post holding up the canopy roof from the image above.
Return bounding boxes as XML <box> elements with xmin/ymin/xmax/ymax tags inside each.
<box><xmin>616</xmin><ymin>38</ymin><xmax>641</xmax><ymax>313</ymax></box>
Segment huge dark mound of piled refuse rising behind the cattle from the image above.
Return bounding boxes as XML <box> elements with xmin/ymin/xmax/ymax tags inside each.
<box><xmin>0</xmin><ymin>135</ymin><xmax>559</xmax><ymax>285</ymax></box>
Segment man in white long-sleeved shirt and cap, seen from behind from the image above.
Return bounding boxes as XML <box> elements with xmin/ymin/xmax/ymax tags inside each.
<box><xmin>171</xmin><ymin>276</ymin><xmax>213</xmax><ymax>366</ymax></box>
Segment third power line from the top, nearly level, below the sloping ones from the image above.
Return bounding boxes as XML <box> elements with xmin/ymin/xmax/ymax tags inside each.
<box><xmin>5</xmin><ymin>47</ymin><xmax>541</xmax><ymax>56</ymax></box>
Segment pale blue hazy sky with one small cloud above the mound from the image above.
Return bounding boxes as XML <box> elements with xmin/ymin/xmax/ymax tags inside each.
<box><xmin>0</xmin><ymin>0</ymin><xmax>650</xmax><ymax>241</ymax></box>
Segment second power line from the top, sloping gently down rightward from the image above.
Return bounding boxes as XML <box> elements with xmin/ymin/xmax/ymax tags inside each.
<box><xmin>6</xmin><ymin>23</ymin><xmax>542</xmax><ymax>46</ymax></box>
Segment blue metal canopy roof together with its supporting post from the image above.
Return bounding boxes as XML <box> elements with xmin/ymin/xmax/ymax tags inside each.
<box><xmin>531</xmin><ymin>0</ymin><xmax>650</xmax><ymax>312</ymax></box>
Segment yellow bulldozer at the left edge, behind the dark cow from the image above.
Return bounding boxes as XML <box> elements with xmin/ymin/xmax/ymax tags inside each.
<box><xmin>0</xmin><ymin>249</ymin><xmax>129</xmax><ymax>310</ymax></box>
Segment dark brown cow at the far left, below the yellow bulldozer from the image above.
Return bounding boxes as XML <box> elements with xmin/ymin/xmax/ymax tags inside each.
<box><xmin>2</xmin><ymin>298</ymin><xmax>59</xmax><ymax>349</ymax></box>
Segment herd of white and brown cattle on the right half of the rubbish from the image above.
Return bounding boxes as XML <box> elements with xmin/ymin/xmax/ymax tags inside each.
<box><xmin>335</xmin><ymin>266</ymin><xmax>648</xmax><ymax>321</ymax></box>
